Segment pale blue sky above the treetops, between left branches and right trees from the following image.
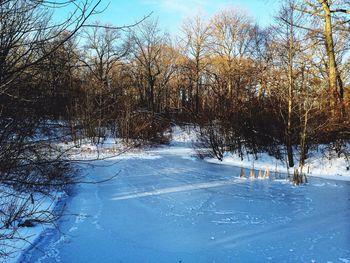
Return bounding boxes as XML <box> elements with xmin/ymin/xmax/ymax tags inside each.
<box><xmin>89</xmin><ymin>0</ymin><xmax>279</xmax><ymax>34</ymax></box>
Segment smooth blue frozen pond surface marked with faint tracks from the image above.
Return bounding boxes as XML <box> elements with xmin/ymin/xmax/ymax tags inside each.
<box><xmin>19</xmin><ymin>127</ymin><xmax>350</xmax><ymax>263</ymax></box>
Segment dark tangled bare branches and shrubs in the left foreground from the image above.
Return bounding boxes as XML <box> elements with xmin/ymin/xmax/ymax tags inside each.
<box><xmin>0</xmin><ymin>0</ymin><xmax>100</xmax><ymax>257</ymax></box>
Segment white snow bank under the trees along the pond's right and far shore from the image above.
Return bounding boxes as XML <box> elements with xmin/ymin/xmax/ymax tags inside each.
<box><xmin>168</xmin><ymin>126</ymin><xmax>350</xmax><ymax>181</ymax></box>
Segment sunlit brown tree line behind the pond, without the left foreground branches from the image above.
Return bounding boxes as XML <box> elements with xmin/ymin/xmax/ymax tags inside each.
<box><xmin>31</xmin><ymin>0</ymin><xmax>350</xmax><ymax>167</ymax></box>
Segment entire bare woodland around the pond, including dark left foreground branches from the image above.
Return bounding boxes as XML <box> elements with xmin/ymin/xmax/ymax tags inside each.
<box><xmin>0</xmin><ymin>0</ymin><xmax>350</xmax><ymax>262</ymax></box>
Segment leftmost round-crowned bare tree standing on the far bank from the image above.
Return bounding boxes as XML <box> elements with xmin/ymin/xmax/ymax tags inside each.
<box><xmin>80</xmin><ymin>23</ymin><xmax>130</xmax><ymax>143</ymax></box>
